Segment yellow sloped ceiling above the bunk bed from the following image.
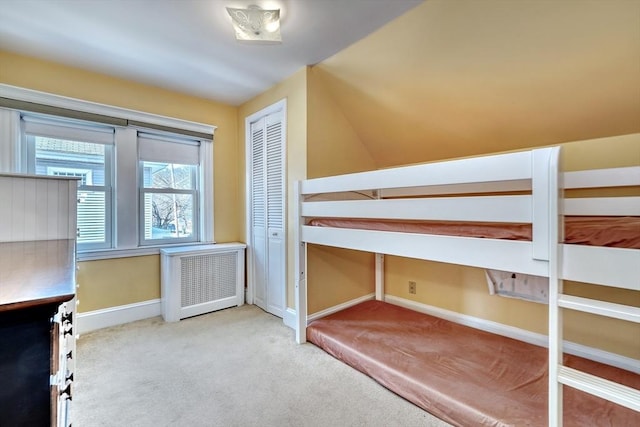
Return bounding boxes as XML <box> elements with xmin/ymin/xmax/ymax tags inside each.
<box><xmin>314</xmin><ymin>0</ymin><xmax>640</xmax><ymax>167</ymax></box>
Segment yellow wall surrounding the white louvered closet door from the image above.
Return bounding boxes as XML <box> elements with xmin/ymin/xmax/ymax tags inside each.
<box><xmin>238</xmin><ymin>68</ymin><xmax>307</xmax><ymax>307</ymax></box>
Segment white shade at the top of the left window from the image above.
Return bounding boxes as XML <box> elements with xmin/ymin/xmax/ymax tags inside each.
<box><xmin>22</xmin><ymin>116</ymin><xmax>115</xmax><ymax>145</ymax></box>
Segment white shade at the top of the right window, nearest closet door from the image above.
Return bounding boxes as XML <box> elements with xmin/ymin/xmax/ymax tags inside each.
<box><xmin>138</xmin><ymin>134</ymin><xmax>200</xmax><ymax>165</ymax></box>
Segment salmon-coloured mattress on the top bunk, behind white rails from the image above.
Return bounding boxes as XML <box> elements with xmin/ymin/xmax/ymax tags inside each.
<box><xmin>309</xmin><ymin>216</ymin><xmax>640</xmax><ymax>249</ymax></box>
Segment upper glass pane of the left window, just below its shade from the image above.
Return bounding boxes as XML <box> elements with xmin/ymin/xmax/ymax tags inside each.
<box><xmin>35</xmin><ymin>136</ymin><xmax>105</xmax><ymax>186</ymax></box>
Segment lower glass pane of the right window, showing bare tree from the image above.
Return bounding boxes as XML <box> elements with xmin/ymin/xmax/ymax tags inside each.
<box><xmin>143</xmin><ymin>193</ymin><xmax>193</xmax><ymax>240</ymax></box>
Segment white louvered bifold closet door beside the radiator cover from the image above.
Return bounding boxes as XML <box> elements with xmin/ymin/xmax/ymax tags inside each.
<box><xmin>250</xmin><ymin>111</ymin><xmax>286</xmax><ymax>317</ymax></box>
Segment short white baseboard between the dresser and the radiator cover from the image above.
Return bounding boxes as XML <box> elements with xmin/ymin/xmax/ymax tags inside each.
<box><xmin>76</xmin><ymin>299</ymin><xmax>162</xmax><ymax>335</ymax></box>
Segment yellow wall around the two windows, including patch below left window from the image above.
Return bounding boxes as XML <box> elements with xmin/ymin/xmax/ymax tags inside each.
<box><xmin>0</xmin><ymin>51</ymin><xmax>244</xmax><ymax>312</ymax></box>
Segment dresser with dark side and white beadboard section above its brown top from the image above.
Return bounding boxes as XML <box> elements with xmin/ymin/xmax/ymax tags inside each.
<box><xmin>0</xmin><ymin>175</ymin><xmax>77</xmax><ymax>427</ymax></box>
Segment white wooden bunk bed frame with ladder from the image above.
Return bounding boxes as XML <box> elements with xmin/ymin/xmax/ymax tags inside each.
<box><xmin>295</xmin><ymin>147</ymin><xmax>640</xmax><ymax>426</ymax></box>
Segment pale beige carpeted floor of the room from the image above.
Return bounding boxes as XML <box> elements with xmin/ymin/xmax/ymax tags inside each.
<box><xmin>72</xmin><ymin>305</ymin><xmax>448</xmax><ymax>427</ymax></box>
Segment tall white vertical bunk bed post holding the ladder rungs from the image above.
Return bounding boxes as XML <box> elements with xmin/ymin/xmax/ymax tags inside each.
<box><xmin>534</xmin><ymin>147</ymin><xmax>563</xmax><ymax>426</ymax></box>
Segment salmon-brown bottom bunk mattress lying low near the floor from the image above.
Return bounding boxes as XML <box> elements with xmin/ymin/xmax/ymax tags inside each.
<box><xmin>307</xmin><ymin>301</ymin><xmax>640</xmax><ymax>426</ymax></box>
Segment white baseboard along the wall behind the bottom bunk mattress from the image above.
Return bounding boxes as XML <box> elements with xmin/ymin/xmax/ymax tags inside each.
<box><xmin>385</xmin><ymin>295</ymin><xmax>640</xmax><ymax>373</ymax></box>
